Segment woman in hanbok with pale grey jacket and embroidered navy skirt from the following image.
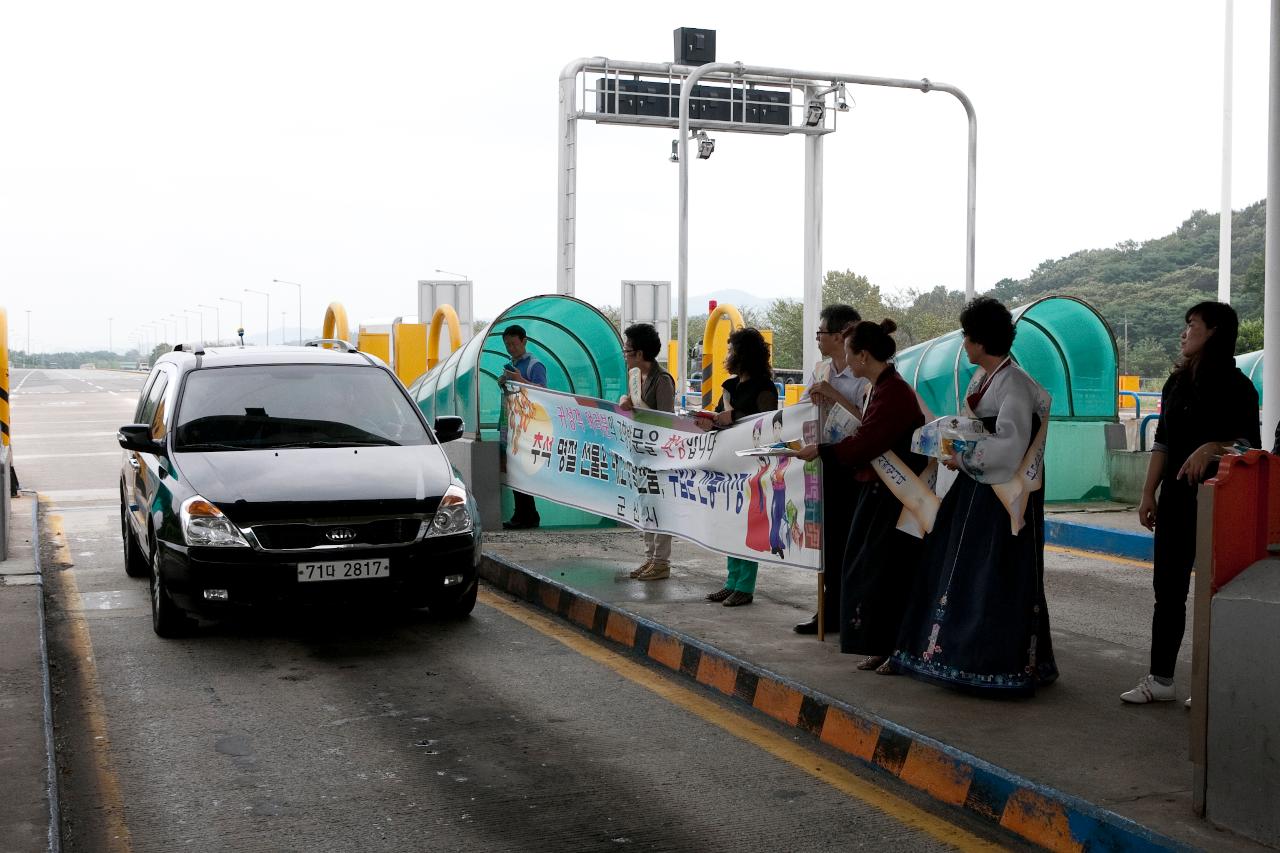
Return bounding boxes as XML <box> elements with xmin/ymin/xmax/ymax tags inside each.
<box><xmin>892</xmin><ymin>297</ymin><xmax>1057</xmax><ymax>695</ymax></box>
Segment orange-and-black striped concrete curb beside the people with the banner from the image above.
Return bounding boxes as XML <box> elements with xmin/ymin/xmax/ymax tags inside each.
<box><xmin>480</xmin><ymin>553</ymin><xmax>1193</xmax><ymax>852</ymax></box>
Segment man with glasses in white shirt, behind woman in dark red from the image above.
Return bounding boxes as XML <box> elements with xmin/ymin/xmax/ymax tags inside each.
<box><xmin>794</xmin><ymin>304</ymin><xmax>870</xmax><ymax>634</ymax></box>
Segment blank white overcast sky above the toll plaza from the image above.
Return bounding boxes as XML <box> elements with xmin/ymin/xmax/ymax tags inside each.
<box><xmin>0</xmin><ymin>0</ymin><xmax>1267</xmax><ymax>351</ymax></box>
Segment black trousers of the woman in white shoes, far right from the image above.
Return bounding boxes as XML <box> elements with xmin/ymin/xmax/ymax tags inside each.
<box><xmin>1151</xmin><ymin>480</ymin><xmax>1197</xmax><ymax>679</ymax></box>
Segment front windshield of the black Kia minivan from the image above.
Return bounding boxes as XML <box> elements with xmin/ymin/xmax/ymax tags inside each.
<box><xmin>174</xmin><ymin>364</ymin><xmax>431</xmax><ymax>452</ymax></box>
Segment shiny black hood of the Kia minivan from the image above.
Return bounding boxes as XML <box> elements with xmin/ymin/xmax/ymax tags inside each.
<box><xmin>174</xmin><ymin>444</ymin><xmax>454</xmax><ymax>524</ymax></box>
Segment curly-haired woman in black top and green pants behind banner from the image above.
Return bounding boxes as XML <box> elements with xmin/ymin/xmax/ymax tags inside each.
<box><xmin>707</xmin><ymin>328</ymin><xmax>778</xmax><ymax>607</ymax></box>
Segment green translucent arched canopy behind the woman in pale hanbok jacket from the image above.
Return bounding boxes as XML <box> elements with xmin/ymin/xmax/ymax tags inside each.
<box><xmin>896</xmin><ymin>296</ymin><xmax>1117</xmax><ymax>501</ymax></box>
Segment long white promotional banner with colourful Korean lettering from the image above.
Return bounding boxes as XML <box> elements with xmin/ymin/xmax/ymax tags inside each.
<box><xmin>503</xmin><ymin>383</ymin><xmax>822</xmax><ymax>569</ymax></box>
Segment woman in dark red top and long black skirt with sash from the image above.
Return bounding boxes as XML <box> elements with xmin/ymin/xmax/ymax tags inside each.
<box><xmin>797</xmin><ymin>320</ymin><xmax>928</xmax><ymax>674</ymax></box>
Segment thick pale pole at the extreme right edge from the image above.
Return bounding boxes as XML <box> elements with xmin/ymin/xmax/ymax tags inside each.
<box><xmin>1262</xmin><ymin>0</ymin><xmax>1280</xmax><ymax>446</ymax></box>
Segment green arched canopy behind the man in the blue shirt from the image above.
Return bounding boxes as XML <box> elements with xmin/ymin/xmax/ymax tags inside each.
<box><xmin>410</xmin><ymin>295</ymin><xmax>626</xmax><ymax>526</ymax></box>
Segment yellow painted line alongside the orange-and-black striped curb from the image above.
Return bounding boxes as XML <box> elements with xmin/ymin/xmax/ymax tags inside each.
<box><xmin>480</xmin><ymin>588</ymin><xmax>1004</xmax><ymax>850</ymax></box>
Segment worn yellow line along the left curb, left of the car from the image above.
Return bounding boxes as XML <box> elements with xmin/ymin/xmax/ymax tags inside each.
<box><xmin>41</xmin><ymin>497</ymin><xmax>133</xmax><ymax>853</ymax></box>
